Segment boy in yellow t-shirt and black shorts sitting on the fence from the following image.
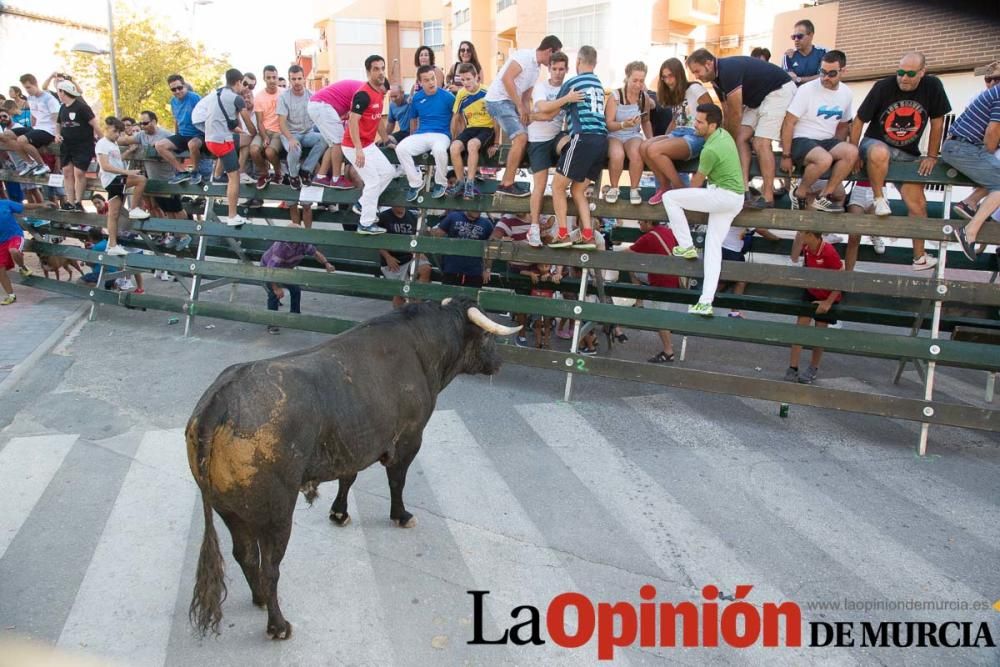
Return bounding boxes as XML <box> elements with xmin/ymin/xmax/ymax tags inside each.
<box><xmin>447</xmin><ymin>63</ymin><xmax>500</xmax><ymax>199</ymax></box>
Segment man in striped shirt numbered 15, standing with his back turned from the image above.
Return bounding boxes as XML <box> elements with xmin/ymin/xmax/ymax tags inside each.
<box><xmin>538</xmin><ymin>46</ymin><xmax>608</xmax><ymax>250</ymax></box>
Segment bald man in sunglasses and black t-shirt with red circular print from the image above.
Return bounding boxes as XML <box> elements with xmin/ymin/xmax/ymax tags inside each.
<box><xmin>851</xmin><ymin>51</ymin><xmax>951</xmax><ymax>271</ymax></box>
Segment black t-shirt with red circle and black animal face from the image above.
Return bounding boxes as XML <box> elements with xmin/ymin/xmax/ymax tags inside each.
<box><xmin>858</xmin><ymin>74</ymin><xmax>951</xmax><ymax>155</ymax></box>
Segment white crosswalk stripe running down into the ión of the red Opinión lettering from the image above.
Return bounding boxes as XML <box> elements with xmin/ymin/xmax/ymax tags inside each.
<box><xmin>517</xmin><ymin>404</ymin><xmax>854</xmax><ymax>664</ymax></box>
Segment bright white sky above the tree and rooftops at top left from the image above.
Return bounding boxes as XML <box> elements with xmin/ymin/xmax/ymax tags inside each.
<box><xmin>17</xmin><ymin>0</ymin><xmax>318</xmax><ymax>77</ymax></box>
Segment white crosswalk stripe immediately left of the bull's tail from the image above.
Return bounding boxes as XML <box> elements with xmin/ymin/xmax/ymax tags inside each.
<box><xmin>59</xmin><ymin>429</ymin><xmax>197</xmax><ymax>665</ymax></box>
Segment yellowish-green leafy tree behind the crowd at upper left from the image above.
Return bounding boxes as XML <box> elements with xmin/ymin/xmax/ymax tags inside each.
<box><xmin>58</xmin><ymin>5</ymin><xmax>228</xmax><ymax>125</ymax></box>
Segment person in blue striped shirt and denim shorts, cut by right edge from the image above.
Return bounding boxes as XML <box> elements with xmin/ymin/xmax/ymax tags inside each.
<box><xmin>941</xmin><ymin>85</ymin><xmax>1000</xmax><ymax>261</ymax></box>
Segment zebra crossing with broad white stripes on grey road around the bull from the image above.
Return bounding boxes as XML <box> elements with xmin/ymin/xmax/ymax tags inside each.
<box><xmin>0</xmin><ymin>393</ymin><xmax>1000</xmax><ymax>666</ymax></box>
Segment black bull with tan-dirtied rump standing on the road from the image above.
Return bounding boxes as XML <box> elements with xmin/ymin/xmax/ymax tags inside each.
<box><xmin>185</xmin><ymin>299</ymin><xmax>517</xmax><ymax>639</ymax></box>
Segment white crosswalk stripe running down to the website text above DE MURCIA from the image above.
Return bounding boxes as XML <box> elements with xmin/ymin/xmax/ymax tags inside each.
<box><xmin>628</xmin><ymin>396</ymin><xmax>983</xmax><ymax>620</ymax></box>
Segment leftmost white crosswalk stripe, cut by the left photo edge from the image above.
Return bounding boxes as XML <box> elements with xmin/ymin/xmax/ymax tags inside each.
<box><xmin>0</xmin><ymin>434</ymin><xmax>77</xmax><ymax>558</ymax></box>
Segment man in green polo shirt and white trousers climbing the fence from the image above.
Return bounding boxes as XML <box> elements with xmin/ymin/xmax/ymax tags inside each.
<box><xmin>663</xmin><ymin>104</ymin><xmax>743</xmax><ymax>317</ymax></box>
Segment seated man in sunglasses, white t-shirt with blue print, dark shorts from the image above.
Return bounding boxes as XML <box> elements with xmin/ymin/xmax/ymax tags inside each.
<box><xmin>781</xmin><ymin>49</ymin><xmax>858</xmax><ymax>213</ymax></box>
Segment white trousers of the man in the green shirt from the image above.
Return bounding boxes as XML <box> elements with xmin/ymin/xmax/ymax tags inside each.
<box><xmin>663</xmin><ymin>185</ymin><xmax>743</xmax><ymax>304</ymax></box>
